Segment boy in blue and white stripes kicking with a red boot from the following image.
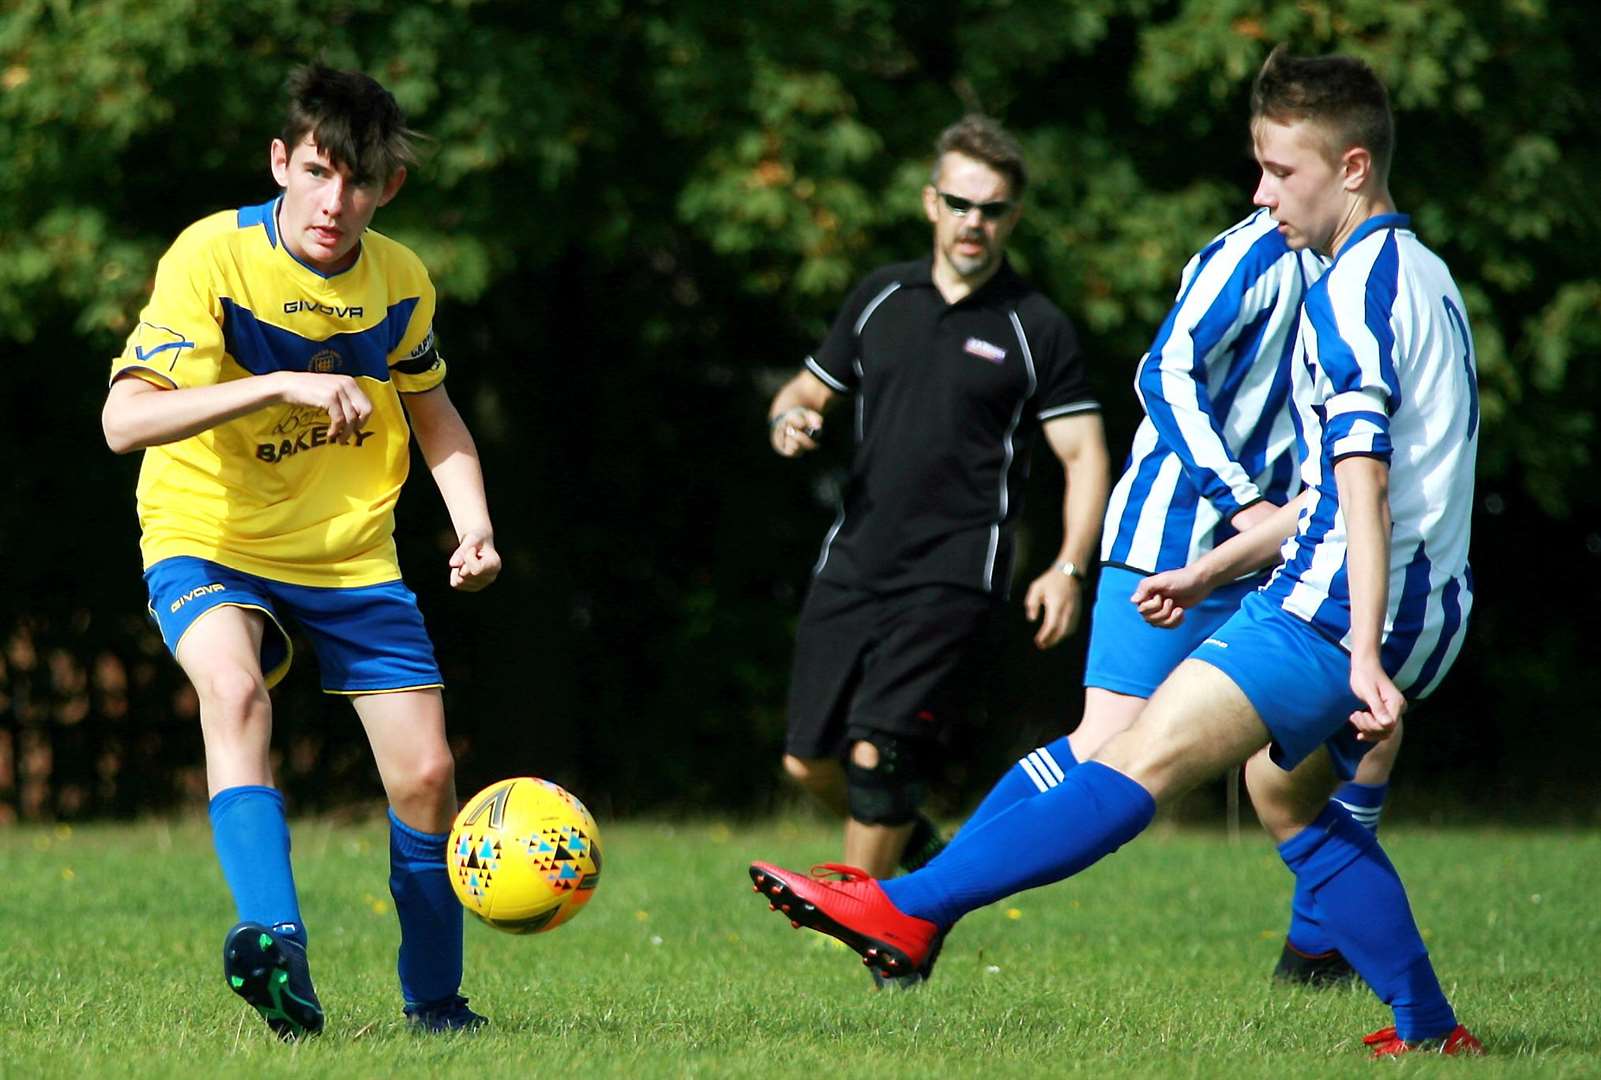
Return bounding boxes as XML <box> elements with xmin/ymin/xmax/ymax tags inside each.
<box><xmin>751</xmin><ymin>51</ymin><xmax>1483</xmax><ymax>1056</ymax></box>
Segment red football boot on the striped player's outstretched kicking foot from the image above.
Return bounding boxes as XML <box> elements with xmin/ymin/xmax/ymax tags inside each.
<box><xmin>751</xmin><ymin>862</ymin><xmax>940</xmax><ymax>976</ymax></box>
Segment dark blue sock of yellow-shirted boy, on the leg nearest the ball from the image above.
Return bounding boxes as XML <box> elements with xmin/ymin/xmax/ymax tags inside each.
<box><xmin>389</xmin><ymin>810</ymin><xmax>461</xmax><ymax>1005</ymax></box>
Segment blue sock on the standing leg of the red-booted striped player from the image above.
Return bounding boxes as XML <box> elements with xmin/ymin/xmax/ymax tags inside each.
<box><xmin>1279</xmin><ymin>803</ymin><xmax>1457</xmax><ymax>1040</ymax></box>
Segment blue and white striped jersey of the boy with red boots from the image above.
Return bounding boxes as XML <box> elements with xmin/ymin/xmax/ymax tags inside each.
<box><xmin>1263</xmin><ymin>214</ymin><xmax>1479</xmax><ymax>696</ymax></box>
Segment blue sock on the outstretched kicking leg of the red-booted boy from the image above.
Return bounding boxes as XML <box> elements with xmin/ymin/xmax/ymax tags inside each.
<box><xmin>879</xmin><ymin>762</ymin><xmax>1156</xmax><ymax>928</ymax></box>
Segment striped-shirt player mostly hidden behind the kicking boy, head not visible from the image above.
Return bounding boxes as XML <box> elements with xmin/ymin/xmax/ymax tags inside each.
<box><xmin>964</xmin><ymin>208</ymin><xmax>1399</xmax><ymax>986</ymax></box>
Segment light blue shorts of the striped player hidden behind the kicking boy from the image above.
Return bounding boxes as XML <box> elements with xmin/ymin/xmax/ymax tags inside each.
<box><xmin>1084</xmin><ymin>566</ymin><xmax>1262</xmax><ymax>698</ymax></box>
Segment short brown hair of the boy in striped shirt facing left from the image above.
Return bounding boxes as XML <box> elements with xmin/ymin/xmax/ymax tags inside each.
<box><xmin>1250</xmin><ymin>45</ymin><xmax>1396</xmax><ymax>179</ymax></box>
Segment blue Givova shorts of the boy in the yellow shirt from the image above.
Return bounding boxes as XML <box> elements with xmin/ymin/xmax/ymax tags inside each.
<box><xmin>144</xmin><ymin>555</ymin><xmax>445</xmax><ymax>694</ymax></box>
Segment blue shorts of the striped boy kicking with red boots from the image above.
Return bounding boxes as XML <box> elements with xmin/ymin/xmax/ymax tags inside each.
<box><xmin>1191</xmin><ymin>592</ymin><xmax>1374</xmax><ymax>779</ymax></box>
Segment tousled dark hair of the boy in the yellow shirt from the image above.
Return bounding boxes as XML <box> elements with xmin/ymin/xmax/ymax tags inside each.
<box><xmin>283</xmin><ymin>62</ymin><xmax>419</xmax><ymax>182</ymax></box>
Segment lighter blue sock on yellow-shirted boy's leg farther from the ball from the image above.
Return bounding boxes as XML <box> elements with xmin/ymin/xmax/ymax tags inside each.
<box><xmin>210</xmin><ymin>784</ymin><xmax>306</xmax><ymax>946</ymax></box>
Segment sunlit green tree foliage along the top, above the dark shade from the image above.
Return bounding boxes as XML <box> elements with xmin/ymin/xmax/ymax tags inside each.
<box><xmin>0</xmin><ymin>0</ymin><xmax>1601</xmax><ymax>492</ymax></box>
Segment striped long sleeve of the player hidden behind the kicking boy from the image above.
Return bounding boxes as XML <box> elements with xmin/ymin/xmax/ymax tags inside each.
<box><xmin>1135</xmin><ymin>214</ymin><xmax>1300</xmax><ymax>518</ymax></box>
